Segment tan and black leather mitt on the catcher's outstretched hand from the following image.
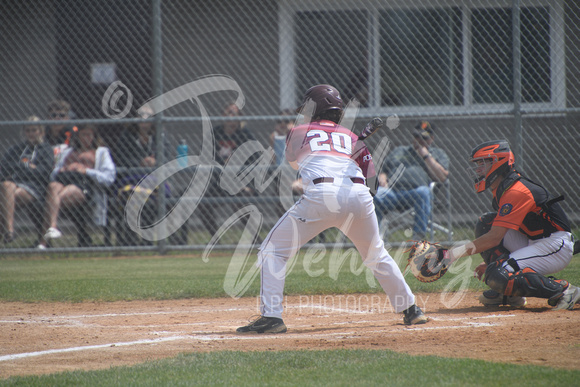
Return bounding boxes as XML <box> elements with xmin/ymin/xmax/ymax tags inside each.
<box><xmin>407</xmin><ymin>241</ymin><xmax>450</xmax><ymax>282</ymax></box>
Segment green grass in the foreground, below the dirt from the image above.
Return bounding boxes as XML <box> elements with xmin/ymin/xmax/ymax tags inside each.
<box><xmin>0</xmin><ymin>350</ymin><xmax>580</xmax><ymax>387</ymax></box>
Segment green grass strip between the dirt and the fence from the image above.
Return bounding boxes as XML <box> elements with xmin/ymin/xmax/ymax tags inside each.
<box><xmin>0</xmin><ymin>249</ymin><xmax>580</xmax><ymax>302</ymax></box>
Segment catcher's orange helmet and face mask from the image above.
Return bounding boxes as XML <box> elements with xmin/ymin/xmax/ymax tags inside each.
<box><xmin>471</xmin><ymin>140</ymin><xmax>515</xmax><ymax>193</ymax></box>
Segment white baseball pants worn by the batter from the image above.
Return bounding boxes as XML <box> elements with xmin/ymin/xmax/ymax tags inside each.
<box><xmin>258</xmin><ymin>179</ymin><xmax>415</xmax><ymax>318</ymax></box>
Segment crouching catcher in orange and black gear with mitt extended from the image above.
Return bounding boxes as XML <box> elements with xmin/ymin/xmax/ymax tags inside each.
<box><xmin>409</xmin><ymin>140</ymin><xmax>580</xmax><ymax>310</ymax></box>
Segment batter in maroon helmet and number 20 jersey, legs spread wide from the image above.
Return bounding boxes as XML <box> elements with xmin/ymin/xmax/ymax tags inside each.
<box><xmin>237</xmin><ymin>85</ymin><xmax>428</xmax><ymax>333</ymax></box>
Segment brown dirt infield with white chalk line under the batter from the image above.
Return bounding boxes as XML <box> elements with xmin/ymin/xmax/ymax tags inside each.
<box><xmin>0</xmin><ymin>293</ymin><xmax>580</xmax><ymax>378</ymax></box>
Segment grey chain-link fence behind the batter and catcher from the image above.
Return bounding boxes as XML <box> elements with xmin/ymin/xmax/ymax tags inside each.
<box><xmin>0</xmin><ymin>0</ymin><xmax>580</xmax><ymax>253</ymax></box>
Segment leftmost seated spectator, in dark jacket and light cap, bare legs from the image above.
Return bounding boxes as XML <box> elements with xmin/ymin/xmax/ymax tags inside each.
<box><xmin>0</xmin><ymin>116</ymin><xmax>54</xmax><ymax>243</ymax></box>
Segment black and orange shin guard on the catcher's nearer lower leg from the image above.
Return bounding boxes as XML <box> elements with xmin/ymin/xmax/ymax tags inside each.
<box><xmin>485</xmin><ymin>260</ymin><xmax>568</xmax><ymax>298</ymax></box>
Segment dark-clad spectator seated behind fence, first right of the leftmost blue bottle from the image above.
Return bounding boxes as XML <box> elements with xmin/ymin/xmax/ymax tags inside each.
<box><xmin>200</xmin><ymin>102</ymin><xmax>255</xmax><ymax>235</ymax></box>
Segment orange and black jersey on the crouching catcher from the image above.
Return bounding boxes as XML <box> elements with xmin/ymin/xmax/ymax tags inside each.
<box><xmin>493</xmin><ymin>171</ymin><xmax>570</xmax><ymax>240</ymax></box>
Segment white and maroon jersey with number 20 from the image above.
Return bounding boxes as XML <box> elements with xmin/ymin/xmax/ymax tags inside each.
<box><xmin>286</xmin><ymin>120</ymin><xmax>375</xmax><ymax>185</ymax></box>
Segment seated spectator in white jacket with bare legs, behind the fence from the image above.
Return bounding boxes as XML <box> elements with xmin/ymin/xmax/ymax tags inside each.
<box><xmin>38</xmin><ymin>124</ymin><xmax>116</xmax><ymax>249</ymax></box>
